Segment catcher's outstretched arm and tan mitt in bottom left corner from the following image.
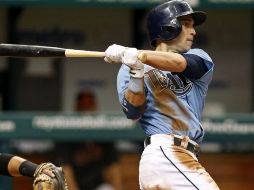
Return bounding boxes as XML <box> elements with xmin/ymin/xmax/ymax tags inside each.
<box><xmin>0</xmin><ymin>153</ymin><xmax>68</xmax><ymax>190</ymax></box>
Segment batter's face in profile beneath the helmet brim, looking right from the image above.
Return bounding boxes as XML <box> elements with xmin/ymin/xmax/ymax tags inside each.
<box><xmin>172</xmin><ymin>15</ymin><xmax>196</xmax><ymax>52</ymax></box>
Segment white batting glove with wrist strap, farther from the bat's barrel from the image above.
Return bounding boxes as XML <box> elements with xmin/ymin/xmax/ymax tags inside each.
<box><xmin>122</xmin><ymin>48</ymin><xmax>144</xmax><ymax>78</ymax></box>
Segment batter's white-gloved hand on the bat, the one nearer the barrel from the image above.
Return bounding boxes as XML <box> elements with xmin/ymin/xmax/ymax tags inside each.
<box><xmin>104</xmin><ymin>44</ymin><xmax>127</xmax><ymax>63</ymax></box>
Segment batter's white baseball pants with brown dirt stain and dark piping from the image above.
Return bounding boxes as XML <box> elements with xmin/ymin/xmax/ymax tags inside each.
<box><xmin>139</xmin><ymin>134</ymin><xmax>219</xmax><ymax>190</ymax></box>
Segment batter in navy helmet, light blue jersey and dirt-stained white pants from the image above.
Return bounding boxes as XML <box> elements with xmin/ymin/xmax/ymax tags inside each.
<box><xmin>105</xmin><ymin>0</ymin><xmax>219</xmax><ymax>190</ymax></box>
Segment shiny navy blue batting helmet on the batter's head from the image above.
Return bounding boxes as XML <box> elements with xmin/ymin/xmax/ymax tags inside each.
<box><xmin>147</xmin><ymin>0</ymin><xmax>206</xmax><ymax>47</ymax></box>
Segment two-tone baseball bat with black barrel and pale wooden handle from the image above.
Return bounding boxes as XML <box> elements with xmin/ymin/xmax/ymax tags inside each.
<box><xmin>0</xmin><ymin>44</ymin><xmax>105</xmax><ymax>57</ymax></box>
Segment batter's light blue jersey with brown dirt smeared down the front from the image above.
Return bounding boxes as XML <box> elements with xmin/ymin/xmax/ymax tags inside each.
<box><xmin>117</xmin><ymin>49</ymin><xmax>214</xmax><ymax>143</ymax></box>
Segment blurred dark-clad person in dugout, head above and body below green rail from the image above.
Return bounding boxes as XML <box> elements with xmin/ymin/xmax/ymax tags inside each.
<box><xmin>55</xmin><ymin>90</ymin><xmax>122</xmax><ymax>190</ymax></box>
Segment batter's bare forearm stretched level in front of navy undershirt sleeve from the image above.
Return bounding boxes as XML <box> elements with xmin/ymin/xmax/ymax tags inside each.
<box><xmin>139</xmin><ymin>50</ymin><xmax>187</xmax><ymax>72</ymax></box>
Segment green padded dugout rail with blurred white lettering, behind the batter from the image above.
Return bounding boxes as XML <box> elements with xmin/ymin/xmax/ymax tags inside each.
<box><xmin>0</xmin><ymin>112</ymin><xmax>254</xmax><ymax>142</ymax></box>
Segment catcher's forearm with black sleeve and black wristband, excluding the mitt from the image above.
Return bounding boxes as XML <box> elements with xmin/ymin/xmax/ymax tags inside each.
<box><xmin>0</xmin><ymin>154</ymin><xmax>38</xmax><ymax>177</ymax></box>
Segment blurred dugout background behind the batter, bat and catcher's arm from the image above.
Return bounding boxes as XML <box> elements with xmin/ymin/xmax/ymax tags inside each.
<box><xmin>0</xmin><ymin>0</ymin><xmax>254</xmax><ymax>190</ymax></box>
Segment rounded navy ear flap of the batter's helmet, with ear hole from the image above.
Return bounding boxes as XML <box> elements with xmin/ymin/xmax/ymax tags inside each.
<box><xmin>159</xmin><ymin>18</ymin><xmax>182</xmax><ymax>40</ymax></box>
